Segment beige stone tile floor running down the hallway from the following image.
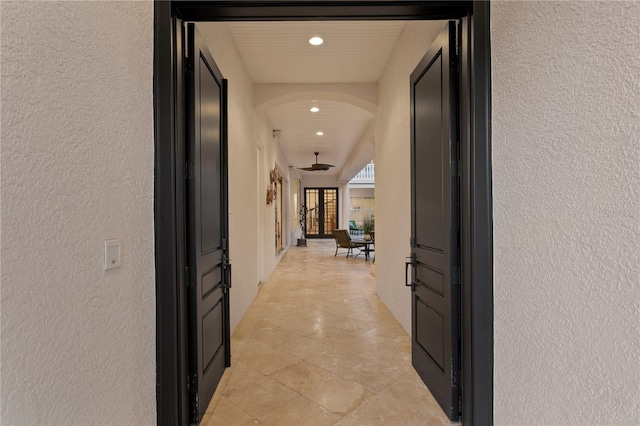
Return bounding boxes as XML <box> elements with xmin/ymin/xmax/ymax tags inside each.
<box><xmin>201</xmin><ymin>240</ymin><xmax>449</xmax><ymax>426</ymax></box>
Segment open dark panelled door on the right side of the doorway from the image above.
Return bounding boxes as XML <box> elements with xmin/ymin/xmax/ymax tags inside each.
<box><xmin>411</xmin><ymin>22</ymin><xmax>460</xmax><ymax>420</ymax></box>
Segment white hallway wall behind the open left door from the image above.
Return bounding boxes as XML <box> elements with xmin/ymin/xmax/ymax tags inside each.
<box><xmin>198</xmin><ymin>23</ymin><xmax>289</xmax><ymax>330</ymax></box>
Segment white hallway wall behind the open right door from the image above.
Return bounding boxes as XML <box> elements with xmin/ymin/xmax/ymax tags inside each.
<box><xmin>375</xmin><ymin>21</ymin><xmax>444</xmax><ymax>333</ymax></box>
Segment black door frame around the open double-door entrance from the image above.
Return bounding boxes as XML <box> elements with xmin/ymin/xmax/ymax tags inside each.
<box><xmin>153</xmin><ymin>0</ymin><xmax>494</xmax><ymax>425</ymax></box>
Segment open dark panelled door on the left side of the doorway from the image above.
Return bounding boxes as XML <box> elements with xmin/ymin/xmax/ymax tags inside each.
<box><xmin>185</xmin><ymin>24</ymin><xmax>231</xmax><ymax>424</ymax></box>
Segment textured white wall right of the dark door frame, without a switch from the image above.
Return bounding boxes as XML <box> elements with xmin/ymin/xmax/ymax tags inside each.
<box><xmin>491</xmin><ymin>1</ymin><xmax>640</xmax><ymax>425</ymax></box>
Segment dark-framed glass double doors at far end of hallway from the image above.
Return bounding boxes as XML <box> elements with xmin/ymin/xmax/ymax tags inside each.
<box><xmin>304</xmin><ymin>188</ymin><xmax>338</xmax><ymax>238</ymax></box>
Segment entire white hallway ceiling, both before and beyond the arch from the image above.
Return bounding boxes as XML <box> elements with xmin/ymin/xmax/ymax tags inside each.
<box><xmin>221</xmin><ymin>21</ymin><xmax>405</xmax><ymax>179</ymax></box>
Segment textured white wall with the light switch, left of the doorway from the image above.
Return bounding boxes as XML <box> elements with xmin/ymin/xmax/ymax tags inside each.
<box><xmin>0</xmin><ymin>1</ymin><xmax>156</xmax><ymax>424</ymax></box>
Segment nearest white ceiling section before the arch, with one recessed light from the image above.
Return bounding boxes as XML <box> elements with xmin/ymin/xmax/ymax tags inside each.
<box><xmin>227</xmin><ymin>21</ymin><xmax>405</xmax><ymax>83</ymax></box>
